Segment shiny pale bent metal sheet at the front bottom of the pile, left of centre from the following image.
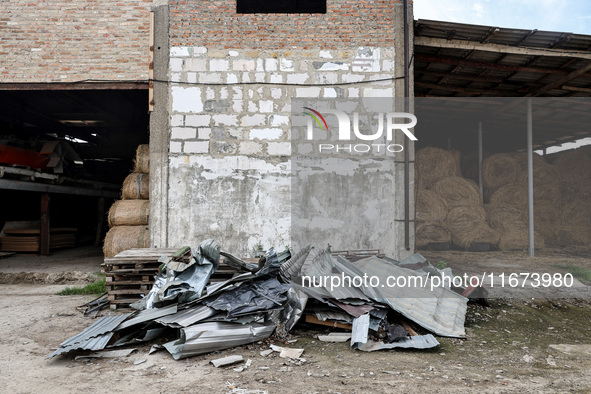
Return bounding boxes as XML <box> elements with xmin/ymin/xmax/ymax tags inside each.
<box><xmin>164</xmin><ymin>322</ymin><xmax>275</xmax><ymax>360</ymax></box>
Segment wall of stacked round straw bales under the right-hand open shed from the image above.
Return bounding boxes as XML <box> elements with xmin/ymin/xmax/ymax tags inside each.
<box><xmin>416</xmin><ymin>148</ymin><xmax>591</xmax><ymax>250</ymax></box>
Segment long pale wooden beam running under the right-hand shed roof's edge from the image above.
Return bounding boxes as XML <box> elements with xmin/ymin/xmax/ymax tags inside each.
<box><xmin>415</xmin><ymin>37</ymin><xmax>591</xmax><ymax>60</ymax></box>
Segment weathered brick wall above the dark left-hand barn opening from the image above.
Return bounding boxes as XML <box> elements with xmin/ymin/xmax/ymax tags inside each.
<box><xmin>0</xmin><ymin>0</ymin><xmax>152</xmax><ymax>82</ymax></box>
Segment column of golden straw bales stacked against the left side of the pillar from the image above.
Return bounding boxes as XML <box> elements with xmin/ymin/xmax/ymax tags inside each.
<box><xmin>103</xmin><ymin>145</ymin><xmax>150</xmax><ymax>257</ymax></box>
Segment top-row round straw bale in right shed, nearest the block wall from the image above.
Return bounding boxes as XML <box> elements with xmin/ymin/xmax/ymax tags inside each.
<box><xmin>415</xmin><ymin>147</ymin><xmax>460</xmax><ymax>189</ymax></box>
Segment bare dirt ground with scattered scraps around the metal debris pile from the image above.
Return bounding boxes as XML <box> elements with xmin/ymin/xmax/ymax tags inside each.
<box><xmin>0</xmin><ymin>248</ymin><xmax>591</xmax><ymax>393</ymax></box>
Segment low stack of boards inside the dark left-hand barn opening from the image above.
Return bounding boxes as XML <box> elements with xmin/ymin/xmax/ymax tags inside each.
<box><xmin>0</xmin><ymin>228</ymin><xmax>77</xmax><ymax>253</ymax></box>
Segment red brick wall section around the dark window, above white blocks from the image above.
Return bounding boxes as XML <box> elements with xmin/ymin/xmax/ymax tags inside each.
<box><xmin>169</xmin><ymin>0</ymin><xmax>399</xmax><ymax>49</ymax></box>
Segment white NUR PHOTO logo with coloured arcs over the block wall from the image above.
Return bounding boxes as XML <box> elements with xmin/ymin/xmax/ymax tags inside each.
<box><xmin>304</xmin><ymin>107</ymin><xmax>417</xmax><ymax>153</ymax></box>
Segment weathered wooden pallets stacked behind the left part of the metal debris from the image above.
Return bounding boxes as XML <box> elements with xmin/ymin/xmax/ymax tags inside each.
<box><xmin>101</xmin><ymin>247</ymin><xmax>247</xmax><ymax>309</ymax></box>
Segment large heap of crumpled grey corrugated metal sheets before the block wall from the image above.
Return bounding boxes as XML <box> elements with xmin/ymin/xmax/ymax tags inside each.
<box><xmin>47</xmin><ymin>240</ymin><xmax>484</xmax><ymax>360</ymax></box>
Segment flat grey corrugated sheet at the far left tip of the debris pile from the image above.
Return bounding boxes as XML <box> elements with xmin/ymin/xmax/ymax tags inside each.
<box><xmin>47</xmin><ymin>313</ymin><xmax>132</xmax><ymax>358</ymax></box>
